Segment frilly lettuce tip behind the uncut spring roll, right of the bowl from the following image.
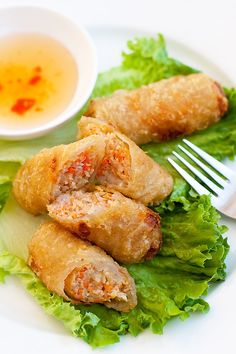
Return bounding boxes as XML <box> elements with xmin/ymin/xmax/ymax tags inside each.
<box><xmin>92</xmin><ymin>34</ymin><xmax>198</xmax><ymax>97</ymax></box>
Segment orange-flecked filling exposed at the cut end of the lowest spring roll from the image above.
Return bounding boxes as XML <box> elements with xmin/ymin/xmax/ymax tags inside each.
<box><xmin>64</xmin><ymin>264</ymin><xmax>127</xmax><ymax>303</ymax></box>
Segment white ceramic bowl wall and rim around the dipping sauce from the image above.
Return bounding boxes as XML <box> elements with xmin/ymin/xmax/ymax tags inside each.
<box><xmin>0</xmin><ymin>6</ymin><xmax>97</xmax><ymax>140</ymax></box>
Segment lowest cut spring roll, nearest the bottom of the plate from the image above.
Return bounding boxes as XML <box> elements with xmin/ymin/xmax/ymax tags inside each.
<box><xmin>28</xmin><ymin>222</ymin><xmax>137</xmax><ymax>312</ymax></box>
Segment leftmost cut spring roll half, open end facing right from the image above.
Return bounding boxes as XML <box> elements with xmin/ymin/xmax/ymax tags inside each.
<box><xmin>13</xmin><ymin>136</ymin><xmax>105</xmax><ymax>214</ymax></box>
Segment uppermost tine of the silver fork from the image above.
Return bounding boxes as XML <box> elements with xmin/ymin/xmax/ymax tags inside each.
<box><xmin>183</xmin><ymin>139</ymin><xmax>234</xmax><ymax>179</ymax></box>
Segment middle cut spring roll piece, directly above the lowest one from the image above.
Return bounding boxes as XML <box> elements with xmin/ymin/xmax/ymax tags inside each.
<box><xmin>48</xmin><ymin>187</ymin><xmax>162</xmax><ymax>263</ymax></box>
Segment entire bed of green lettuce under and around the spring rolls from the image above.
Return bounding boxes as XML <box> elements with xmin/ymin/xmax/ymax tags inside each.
<box><xmin>0</xmin><ymin>35</ymin><xmax>230</xmax><ymax>347</ymax></box>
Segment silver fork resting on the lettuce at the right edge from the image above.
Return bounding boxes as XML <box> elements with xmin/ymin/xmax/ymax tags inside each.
<box><xmin>168</xmin><ymin>139</ymin><xmax>236</xmax><ymax>219</ymax></box>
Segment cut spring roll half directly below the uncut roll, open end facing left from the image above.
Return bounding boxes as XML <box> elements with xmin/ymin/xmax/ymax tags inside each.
<box><xmin>77</xmin><ymin>117</ymin><xmax>173</xmax><ymax>205</ymax></box>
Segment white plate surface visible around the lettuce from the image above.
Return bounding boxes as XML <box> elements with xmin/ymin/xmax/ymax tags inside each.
<box><xmin>0</xmin><ymin>27</ymin><xmax>236</xmax><ymax>354</ymax></box>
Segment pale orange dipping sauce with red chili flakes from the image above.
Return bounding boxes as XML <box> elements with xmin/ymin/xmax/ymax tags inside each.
<box><xmin>0</xmin><ymin>34</ymin><xmax>78</xmax><ymax>129</ymax></box>
